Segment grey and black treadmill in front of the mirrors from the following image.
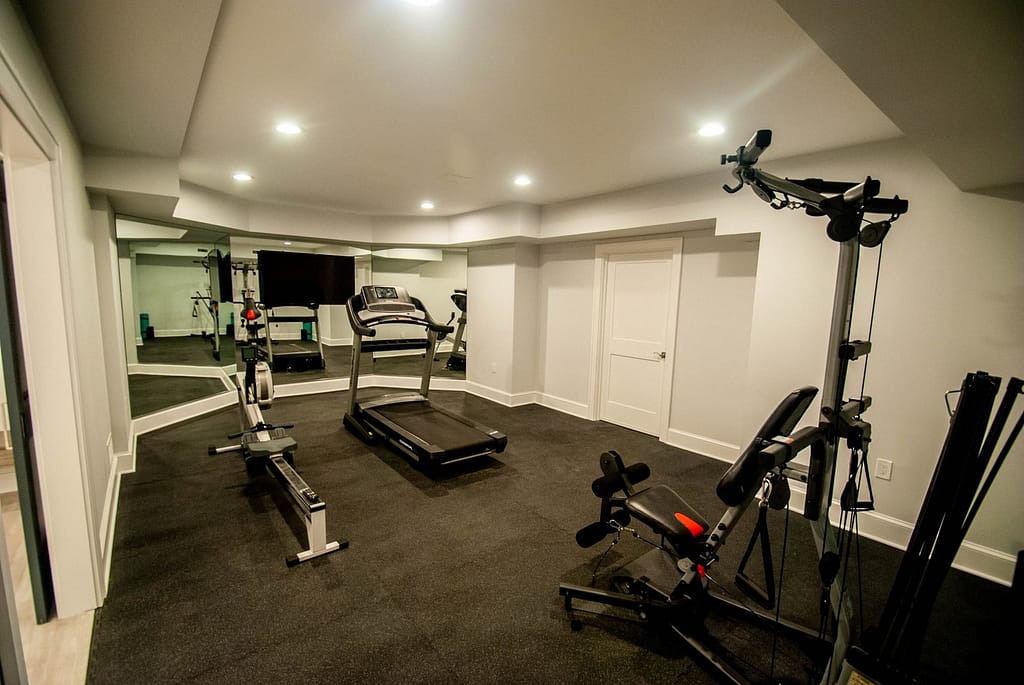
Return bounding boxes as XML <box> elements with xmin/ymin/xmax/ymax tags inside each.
<box><xmin>344</xmin><ymin>286</ymin><xmax>508</xmax><ymax>468</ymax></box>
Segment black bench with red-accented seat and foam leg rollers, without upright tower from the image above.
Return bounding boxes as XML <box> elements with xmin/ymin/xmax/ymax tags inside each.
<box><xmin>559</xmin><ymin>386</ymin><xmax>822</xmax><ymax>683</ymax></box>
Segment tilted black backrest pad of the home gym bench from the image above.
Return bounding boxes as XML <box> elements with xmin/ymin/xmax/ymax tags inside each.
<box><xmin>716</xmin><ymin>386</ymin><xmax>818</xmax><ymax>507</ymax></box>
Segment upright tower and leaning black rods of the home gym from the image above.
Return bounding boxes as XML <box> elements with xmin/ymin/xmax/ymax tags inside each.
<box><xmin>721</xmin><ymin>130</ymin><xmax>1024</xmax><ymax>683</ymax></box>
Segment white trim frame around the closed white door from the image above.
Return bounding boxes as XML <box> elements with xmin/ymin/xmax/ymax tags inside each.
<box><xmin>588</xmin><ymin>236</ymin><xmax>683</xmax><ymax>440</ymax></box>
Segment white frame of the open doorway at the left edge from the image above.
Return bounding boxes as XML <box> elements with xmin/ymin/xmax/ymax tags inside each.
<box><xmin>0</xmin><ymin>34</ymin><xmax>103</xmax><ymax>617</ymax></box>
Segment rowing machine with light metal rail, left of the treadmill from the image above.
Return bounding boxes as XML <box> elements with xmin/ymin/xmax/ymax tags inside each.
<box><xmin>209</xmin><ymin>291</ymin><xmax>348</xmax><ymax>566</ymax></box>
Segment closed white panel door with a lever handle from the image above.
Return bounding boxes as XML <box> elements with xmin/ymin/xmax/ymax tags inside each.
<box><xmin>599</xmin><ymin>241</ymin><xmax>681</xmax><ymax>435</ymax></box>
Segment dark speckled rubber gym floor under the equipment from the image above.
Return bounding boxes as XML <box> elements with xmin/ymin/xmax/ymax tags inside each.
<box><xmin>87</xmin><ymin>392</ymin><xmax>1019</xmax><ymax>684</ymax></box>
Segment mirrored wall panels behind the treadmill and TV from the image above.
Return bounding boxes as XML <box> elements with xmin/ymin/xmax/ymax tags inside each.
<box><xmin>117</xmin><ymin>217</ymin><xmax>471</xmax><ymax>418</ymax></box>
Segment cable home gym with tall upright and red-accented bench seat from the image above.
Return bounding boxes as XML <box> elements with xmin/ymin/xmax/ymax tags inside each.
<box><xmin>560</xmin><ymin>130</ymin><xmax>908</xmax><ymax>685</ymax></box>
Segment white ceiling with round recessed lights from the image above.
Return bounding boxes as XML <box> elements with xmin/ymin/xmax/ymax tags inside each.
<box><xmin>18</xmin><ymin>0</ymin><xmax>1024</xmax><ymax>215</ymax></box>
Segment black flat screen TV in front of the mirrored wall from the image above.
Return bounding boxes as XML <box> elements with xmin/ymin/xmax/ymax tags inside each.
<box><xmin>256</xmin><ymin>250</ymin><xmax>355</xmax><ymax>308</ymax></box>
